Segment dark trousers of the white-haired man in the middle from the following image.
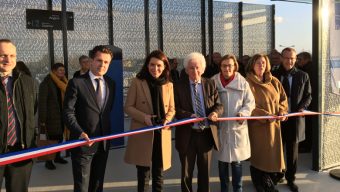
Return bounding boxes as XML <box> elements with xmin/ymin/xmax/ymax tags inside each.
<box><xmin>179</xmin><ymin>129</ymin><xmax>214</xmax><ymax>192</ymax></box>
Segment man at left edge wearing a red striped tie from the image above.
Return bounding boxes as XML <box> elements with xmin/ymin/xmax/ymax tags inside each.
<box><xmin>0</xmin><ymin>39</ymin><xmax>37</xmax><ymax>192</ymax></box>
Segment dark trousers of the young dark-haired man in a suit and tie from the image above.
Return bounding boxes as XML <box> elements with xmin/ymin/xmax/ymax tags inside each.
<box><xmin>71</xmin><ymin>142</ymin><xmax>109</xmax><ymax>192</ymax></box>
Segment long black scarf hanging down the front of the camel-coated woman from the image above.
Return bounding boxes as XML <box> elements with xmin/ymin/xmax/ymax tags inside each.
<box><xmin>146</xmin><ymin>73</ymin><xmax>167</xmax><ymax>125</ymax></box>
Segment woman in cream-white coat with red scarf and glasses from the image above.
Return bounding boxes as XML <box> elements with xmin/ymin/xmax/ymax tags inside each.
<box><xmin>212</xmin><ymin>55</ymin><xmax>255</xmax><ymax>192</ymax></box>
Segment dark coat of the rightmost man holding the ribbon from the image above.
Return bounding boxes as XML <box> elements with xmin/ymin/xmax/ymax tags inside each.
<box><xmin>273</xmin><ymin>66</ymin><xmax>312</xmax><ymax>142</ymax></box>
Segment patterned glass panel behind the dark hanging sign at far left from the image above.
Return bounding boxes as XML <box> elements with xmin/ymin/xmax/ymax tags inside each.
<box><xmin>0</xmin><ymin>0</ymin><xmax>49</xmax><ymax>81</ymax></box>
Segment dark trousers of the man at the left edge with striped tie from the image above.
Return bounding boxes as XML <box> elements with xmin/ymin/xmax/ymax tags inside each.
<box><xmin>0</xmin><ymin>146</ymin><xmax>33</xmax><ymax>192</ymax></box>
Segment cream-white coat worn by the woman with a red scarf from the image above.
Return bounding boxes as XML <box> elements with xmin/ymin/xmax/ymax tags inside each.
<box><xmin>212</xmin><ymin>72</ymin><xmax>255</xmax><ymax>163</ymax></box>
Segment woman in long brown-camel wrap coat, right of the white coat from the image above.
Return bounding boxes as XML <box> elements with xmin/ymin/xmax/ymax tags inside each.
<box><xmin>246</xmin><ymin>54</ymin><xmax>288</xmax><ymax>192</ymax></box>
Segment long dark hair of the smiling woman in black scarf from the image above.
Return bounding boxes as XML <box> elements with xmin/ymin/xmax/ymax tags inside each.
<box><xmin>137</xmin><ymin>50</ymin><xmax>170</xmax><ymax>81</ymax></box>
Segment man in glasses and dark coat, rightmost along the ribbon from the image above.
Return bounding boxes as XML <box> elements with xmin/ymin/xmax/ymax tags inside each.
<box><xmin>273</xmin><ymin>48</ymin><xmax>312</xmax><ymax>192</ymax></box>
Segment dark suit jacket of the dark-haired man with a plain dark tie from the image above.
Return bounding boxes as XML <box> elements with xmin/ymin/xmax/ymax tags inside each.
<box><xmin>64</xmin><ymin>73</ymin><xmax>115</xmax><ymax>152</ymax></box>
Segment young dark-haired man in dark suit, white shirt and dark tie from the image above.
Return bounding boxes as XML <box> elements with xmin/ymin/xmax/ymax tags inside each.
<box><xmin>64</xmin><ymin>45</ymin><xmax>115</xmax><ymax>192</ymax></box>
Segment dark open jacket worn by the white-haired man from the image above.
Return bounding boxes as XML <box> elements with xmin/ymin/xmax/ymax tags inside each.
<box><xmin>175</xmin><ymin>77</ymin><xmax>223</xmax><ymax>153</ymax></box>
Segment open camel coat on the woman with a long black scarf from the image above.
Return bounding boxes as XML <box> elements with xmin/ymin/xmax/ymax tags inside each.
<box><xmin>124</xmin><ymin>78</ymin><xmax>175</xmax><ymax>170</ymax></box>
